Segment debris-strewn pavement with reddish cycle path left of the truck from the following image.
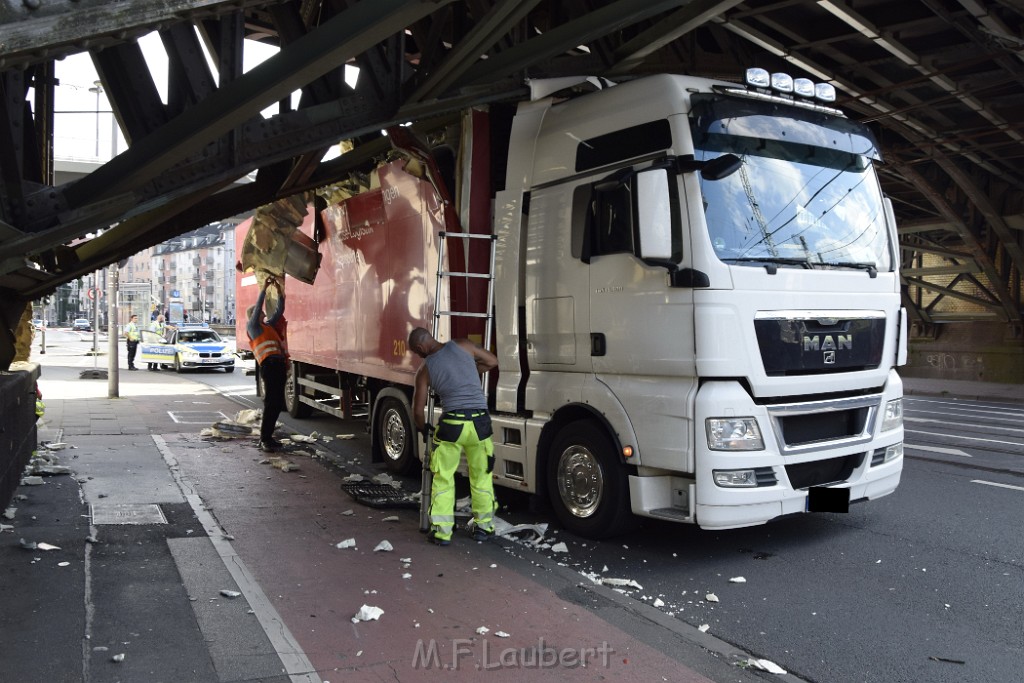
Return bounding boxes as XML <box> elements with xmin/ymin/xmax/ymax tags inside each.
<box><xmin>0</xmin><ymin>344</ymin><xmax>770</xmax><ymax>683</ymax></box>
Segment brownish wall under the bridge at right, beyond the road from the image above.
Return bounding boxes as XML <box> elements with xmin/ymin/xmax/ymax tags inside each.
<box><xmin>900</xmin><ymin>323</ymin><xmax>1024</xmax><ymax>384</ymax></box>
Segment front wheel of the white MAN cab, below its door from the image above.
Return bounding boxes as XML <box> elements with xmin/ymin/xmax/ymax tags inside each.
<box><xmin>547</xmin><ymin>420</ymin><xmax>636</xmax><ymax>539</ymax></box>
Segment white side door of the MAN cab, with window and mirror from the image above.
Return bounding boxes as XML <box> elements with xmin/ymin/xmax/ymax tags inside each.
<box><xmin>588</xmin><ymin>166</ymin><xmax>696</xmax><ymax>470</ymax></box>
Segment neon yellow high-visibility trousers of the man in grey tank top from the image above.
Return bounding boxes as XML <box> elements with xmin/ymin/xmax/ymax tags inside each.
<box><xmin>430</xmin><ymin>418</ymin><xmax>498</xmax><ymax>539</ymax></box>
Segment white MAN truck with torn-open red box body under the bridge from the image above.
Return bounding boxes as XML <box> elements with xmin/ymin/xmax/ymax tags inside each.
<box><xmin>239</xmin><ymin>70</ymin><xmax>907</xmax><ymax>538</ymax></box>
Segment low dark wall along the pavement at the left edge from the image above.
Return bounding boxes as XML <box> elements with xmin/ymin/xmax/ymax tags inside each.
<box><xmin>0</xmin><ymin>362</ymin><xmax>39</xmax><ymax>510</ymax></box>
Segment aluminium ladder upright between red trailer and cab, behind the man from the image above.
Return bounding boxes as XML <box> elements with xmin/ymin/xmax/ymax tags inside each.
<box><xmin>420</xmin><ymin>230</ymin><xmax>498</xmax><ymax>531</ymax></box>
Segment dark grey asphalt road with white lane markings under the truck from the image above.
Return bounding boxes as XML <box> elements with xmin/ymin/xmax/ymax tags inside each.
<box><xmin>79</xmin><ymin>339</ymin><xmax>1024</xmax><ymax>683</ymax></box>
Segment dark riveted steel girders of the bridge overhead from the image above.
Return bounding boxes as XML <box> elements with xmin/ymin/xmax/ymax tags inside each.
<box><xmin>0</xmin><ymin>0</ymin><xmax>1024</xmax><ymax>370</ymax></box>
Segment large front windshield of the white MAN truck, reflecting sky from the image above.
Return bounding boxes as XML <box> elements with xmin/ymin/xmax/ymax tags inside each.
<box><xmin>690</xmin><ymin>94</ymin><xmax>892</xmax><ymax>271</ymax></box>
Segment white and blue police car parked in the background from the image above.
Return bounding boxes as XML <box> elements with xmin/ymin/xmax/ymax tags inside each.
<box><xmin>138</xmin><ymin>325</ymin><xmax>234</xmax><ymax>373</ymax></box>
